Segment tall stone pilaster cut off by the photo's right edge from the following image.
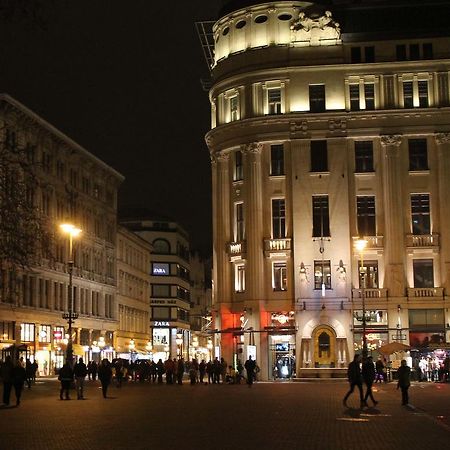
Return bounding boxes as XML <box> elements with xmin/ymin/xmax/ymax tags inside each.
<box><xmin>436</xmin><ymin>133</ymin><xmax>450</xmax><ymax>292</ymax></box>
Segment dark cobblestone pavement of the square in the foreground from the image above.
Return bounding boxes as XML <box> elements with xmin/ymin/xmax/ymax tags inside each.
<box><xmin>0</xmin><ymin>380</ymin><xmax>450</xmax><ymax>450</ymax></box>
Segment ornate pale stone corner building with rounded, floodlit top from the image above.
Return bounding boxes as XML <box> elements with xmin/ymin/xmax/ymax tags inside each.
<box><xmin>201</xmin><ymin>0</ymin><xmax>450</xmax><ymax>379</ymax></box>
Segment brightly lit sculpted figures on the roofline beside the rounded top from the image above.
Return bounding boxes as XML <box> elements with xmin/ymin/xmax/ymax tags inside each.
<box><xmin>291</xmin><ymin>11</ymin><xmax>341</xmax><ymax>45</ymax></box>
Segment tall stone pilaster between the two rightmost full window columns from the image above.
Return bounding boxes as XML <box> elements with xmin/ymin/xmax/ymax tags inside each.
<box><xmin>381</xmin><ymin>135</ymin><xmax>406</xmax><ymax>297</ymax></box>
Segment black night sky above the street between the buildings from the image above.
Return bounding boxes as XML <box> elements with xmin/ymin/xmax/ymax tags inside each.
<box><xmin>0</xmin><ymin>0</ymin><xmax>220</xmax><ymax>252</ymax></box>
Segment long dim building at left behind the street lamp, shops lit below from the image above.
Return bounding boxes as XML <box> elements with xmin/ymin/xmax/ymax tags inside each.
<box><xmin>0</xmin><ymin>95</ymin><xmax>123</xmax><ymax>375</ymax></box>
